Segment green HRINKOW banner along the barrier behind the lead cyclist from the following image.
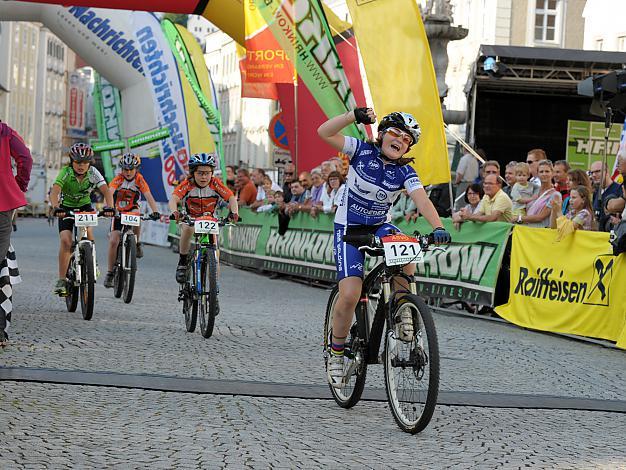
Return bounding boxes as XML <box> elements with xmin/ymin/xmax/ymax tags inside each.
<box><xmin>211</xmin><ymin>208</ymin><xmax>512</xmax><ymax>305</ymax></box>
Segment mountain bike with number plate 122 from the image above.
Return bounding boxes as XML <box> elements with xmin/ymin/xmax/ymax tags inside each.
<box><xmin>172</xmin><ymin>215</ymin><xmax>235</xmax><ymax>338</ymax></box>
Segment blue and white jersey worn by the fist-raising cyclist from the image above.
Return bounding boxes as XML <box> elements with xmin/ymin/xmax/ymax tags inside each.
<box><xmin>335</xmin><ymin>137</ymin><xmax>423</xmax><ymax>225</ymax></box>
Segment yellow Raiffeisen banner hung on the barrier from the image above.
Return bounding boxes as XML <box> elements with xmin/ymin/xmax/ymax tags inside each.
<box><xmin>496</xmin><ymin>227</ymin><xmax>626</xmax><ymax>349</ymax></box>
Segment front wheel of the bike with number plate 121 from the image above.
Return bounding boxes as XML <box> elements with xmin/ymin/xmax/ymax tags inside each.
<box><xmin>383</xmin><ymin>295</ymin><xmax>439</xmax><ymax>434</ymax></box>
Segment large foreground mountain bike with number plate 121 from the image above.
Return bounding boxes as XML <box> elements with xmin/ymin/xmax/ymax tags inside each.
<box><xmin>324</xmin><ymin>233</ymin><xmax>439</xmax><ymax>434</ymax></box>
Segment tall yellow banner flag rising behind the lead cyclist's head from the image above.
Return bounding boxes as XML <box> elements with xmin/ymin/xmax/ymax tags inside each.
<box><xmin>347</xmin><ymin>0</ymin><xmax>450</xmax><ymax>184</ymax></box>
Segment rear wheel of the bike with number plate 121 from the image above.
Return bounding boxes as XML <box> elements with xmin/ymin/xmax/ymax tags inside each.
<box><xmin>324</xmin><ymin>286</ymin><xmax>367</xmax><ymax>408</ymax></box>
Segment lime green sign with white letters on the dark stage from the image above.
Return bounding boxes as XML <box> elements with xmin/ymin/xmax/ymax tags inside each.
<box><xmin>566</xmin><ymin>121</ymin><xmax>623</xmax><ymax>171</ymax></box>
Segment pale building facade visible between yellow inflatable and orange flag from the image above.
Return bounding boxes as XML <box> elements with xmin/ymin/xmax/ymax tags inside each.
<box><xmin>205</xmin><ymin>30</ymin><xmax>276</xmax><ymax>168</ymax></box>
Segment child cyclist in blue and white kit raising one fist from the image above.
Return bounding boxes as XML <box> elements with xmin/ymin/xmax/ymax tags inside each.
<box><xmin>317</xmin><ymin>108</ymin><xmax>451</xmax><ymax>388</ymax></box>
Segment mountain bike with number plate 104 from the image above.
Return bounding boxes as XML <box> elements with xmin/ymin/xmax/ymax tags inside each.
<box><xmin>113</xmin><ymin>212</ymin><xmax>150</xmax><ymax>304</ymax></box>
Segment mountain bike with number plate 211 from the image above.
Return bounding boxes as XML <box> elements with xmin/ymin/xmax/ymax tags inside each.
<box><xmin>64</xmin><ymin>211</ymin><xmax>108</xmax><ymax>320</ymax></box>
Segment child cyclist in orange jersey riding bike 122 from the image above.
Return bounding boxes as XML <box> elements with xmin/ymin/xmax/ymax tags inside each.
<box><xmin>169</xmin><ymin>153</ymin><xmax>239</xmax><ymax>284</ymax></box>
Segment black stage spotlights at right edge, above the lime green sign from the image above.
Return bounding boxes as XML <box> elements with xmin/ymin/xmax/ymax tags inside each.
<box><xmin>578</xmin><ymin>70</ymin><xmax>626</xmax><ymax>117</ymax></box>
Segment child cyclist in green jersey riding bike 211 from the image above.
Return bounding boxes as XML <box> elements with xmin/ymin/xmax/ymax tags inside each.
<box><xmin>50</xmin><ymin>143</ymin><xmax>115</xmax><ymax>297</ymax></box>
